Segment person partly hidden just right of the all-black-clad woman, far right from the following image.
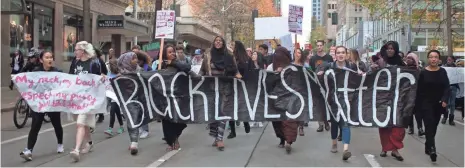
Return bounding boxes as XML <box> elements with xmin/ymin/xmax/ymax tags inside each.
<box><xmin>441</xmin><ymin>56</ymin><xmax>460</xmax><ymax>126</ymax></box>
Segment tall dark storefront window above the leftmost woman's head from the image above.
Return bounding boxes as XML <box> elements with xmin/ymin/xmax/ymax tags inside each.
<box><xmin>32</xmin><ymin>4</ymin><xmax>53</xmax><ymax>51</ymax></box>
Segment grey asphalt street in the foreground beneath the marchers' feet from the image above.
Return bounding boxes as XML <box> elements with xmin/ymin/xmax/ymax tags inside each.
<box><xmin>1</xmin><ymin>112</ymin><xmax>464</xmax><ymax>167</ymax></box>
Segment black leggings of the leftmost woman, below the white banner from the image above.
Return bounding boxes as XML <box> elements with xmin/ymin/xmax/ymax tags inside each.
<box><xmin>27</xmin><ymin>112</ymin><xmax>63</xmax><ymax>151</ymax></box>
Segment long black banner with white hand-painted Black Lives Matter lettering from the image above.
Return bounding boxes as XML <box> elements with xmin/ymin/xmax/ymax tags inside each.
<box><xmin>112</xmin><ymin>65</ymin><xmax>418</xmax><ymax>128</ymax></box>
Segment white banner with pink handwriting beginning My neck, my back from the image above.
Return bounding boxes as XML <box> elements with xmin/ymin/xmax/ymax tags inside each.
<box><xmin>12</xmin><ymin>72</ymin><xmax>108</xmax><ymax>114</ymax></box>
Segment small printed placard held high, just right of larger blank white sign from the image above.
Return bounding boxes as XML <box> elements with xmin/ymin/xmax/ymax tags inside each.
<box><xmin>288</xmin><ymin>5</ymin><xmax>304</xmax><ymax>35</ymax></box>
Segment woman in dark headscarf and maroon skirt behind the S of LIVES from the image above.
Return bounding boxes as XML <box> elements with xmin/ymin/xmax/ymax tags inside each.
<box><xmin>267</xmin><ymin>47</ymin><xmax>300</xmax><ymax>154</ymax></box>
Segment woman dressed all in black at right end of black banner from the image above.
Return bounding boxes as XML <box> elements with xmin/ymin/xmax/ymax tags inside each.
<box><xmin>416</xmin><ymin>50</ymin><xmax>450</xmax><ymax>162</ymax></box>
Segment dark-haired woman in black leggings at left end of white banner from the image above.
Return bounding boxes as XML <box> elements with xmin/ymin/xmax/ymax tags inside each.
<box><xmin>19</xmin><ymin>51</ymin><xmax>64</xmax><ymax>161</ymax></box>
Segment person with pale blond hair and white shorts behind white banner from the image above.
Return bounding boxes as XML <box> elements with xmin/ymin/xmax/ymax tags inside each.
<box><xmin>70</xmin><ymin>41</ymin><xmax>102</xmax><ymax>162</ymax></box>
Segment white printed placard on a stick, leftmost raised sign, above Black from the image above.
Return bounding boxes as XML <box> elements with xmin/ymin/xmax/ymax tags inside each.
<box><xmin>155</xmin><ymin>10</ymin><xmax>176</xmax><ymax>39</ymax></box>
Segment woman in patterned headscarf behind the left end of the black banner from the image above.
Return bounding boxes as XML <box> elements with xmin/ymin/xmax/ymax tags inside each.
<box><xmin>116</xmin><ymin>52</ymin><xmax>142</xmax><ymax>155</ymax></box>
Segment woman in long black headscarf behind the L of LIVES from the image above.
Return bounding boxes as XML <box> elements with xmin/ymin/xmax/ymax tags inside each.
<box><xmin>199</xmin><ymin>36</ymin><xmax>242</xmax><ymax>151</ymax></box>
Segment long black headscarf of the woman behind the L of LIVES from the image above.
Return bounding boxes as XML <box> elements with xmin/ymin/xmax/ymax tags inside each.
<box><xmin>210</xmin><ymin>36</ymin><xmax>237</xmax><ymax>73</ymax></box>
